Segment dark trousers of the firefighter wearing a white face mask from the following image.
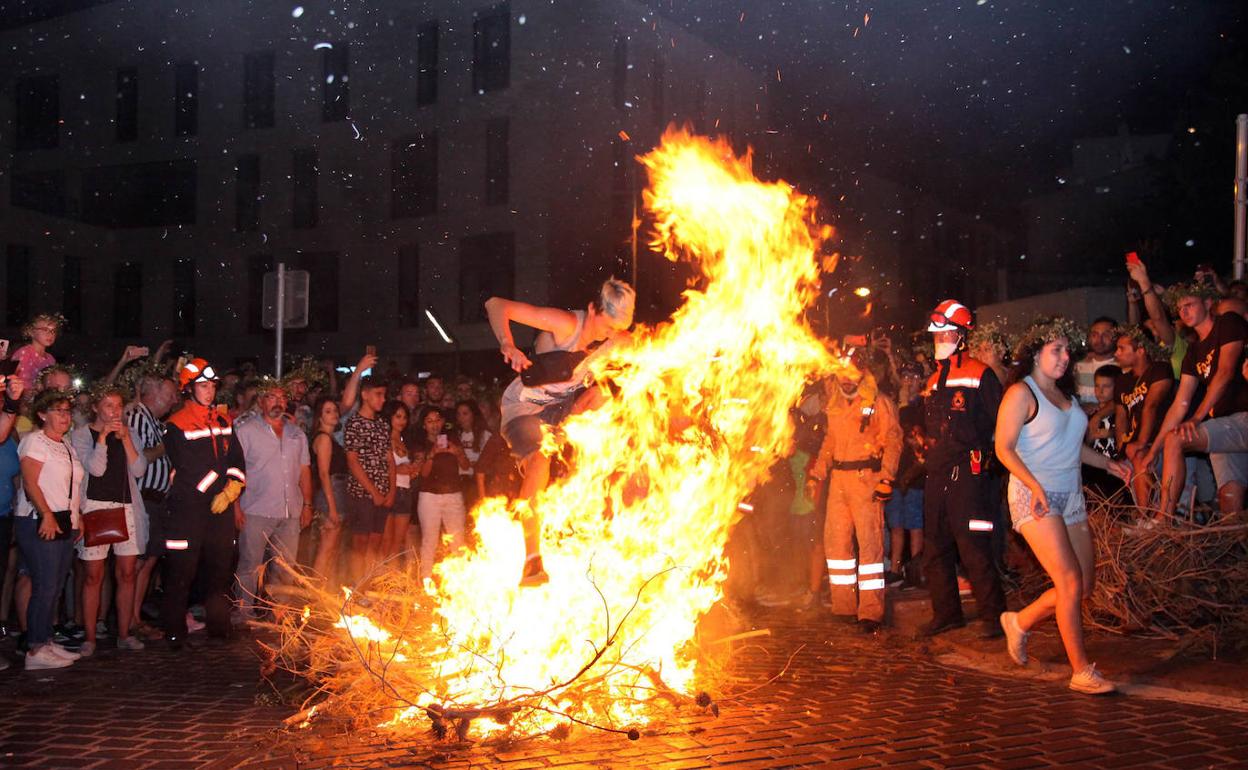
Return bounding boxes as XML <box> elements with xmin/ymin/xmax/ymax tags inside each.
<box><xmin>924</xmin><ymin>461</ymin><xmax>1006</xmax><ymax>625</ymax></box>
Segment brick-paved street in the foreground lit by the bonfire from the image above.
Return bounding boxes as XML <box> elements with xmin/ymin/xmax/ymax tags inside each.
<box><xmin>0</xmin><ymin>613</ymin><xmax>1248</xmax><ymax>770</ymax></box>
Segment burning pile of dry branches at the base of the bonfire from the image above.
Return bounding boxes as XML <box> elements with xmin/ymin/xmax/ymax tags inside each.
<box><xmin>260</xmin><ymin>559</ymin><xmax>719</xmax><ymax>741</ymax></box>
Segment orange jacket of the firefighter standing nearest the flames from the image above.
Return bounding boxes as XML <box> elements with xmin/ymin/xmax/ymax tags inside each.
<box><xmin>810</xmin><ymin>392</ymin><xmax>901</xmax><ymax>480</ymax></box>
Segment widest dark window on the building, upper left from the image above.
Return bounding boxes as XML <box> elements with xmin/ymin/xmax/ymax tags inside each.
<box><xmin>82</xmin><ymin>161</ymin><xmax>198</xmax><ymax>227</ymax></box>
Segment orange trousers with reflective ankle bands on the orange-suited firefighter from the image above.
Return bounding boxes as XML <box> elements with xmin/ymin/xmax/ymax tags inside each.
<box><xmin>824</xmin><ymin>470</ymin><xmax>885</xmax><ymax>623</ymax></box>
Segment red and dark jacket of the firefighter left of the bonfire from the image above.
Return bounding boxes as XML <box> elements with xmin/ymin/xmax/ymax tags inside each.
<box><xmin>165</xmin><ymin>399</ymin><xmax>247</xmax><ymax>509</ymax></box>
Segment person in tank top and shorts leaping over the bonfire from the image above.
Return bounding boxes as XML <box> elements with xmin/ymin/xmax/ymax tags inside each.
<box><xmin>485</xmin><ymin>278</ymin><xmax>636</xmax><ymax>585</ymax></box>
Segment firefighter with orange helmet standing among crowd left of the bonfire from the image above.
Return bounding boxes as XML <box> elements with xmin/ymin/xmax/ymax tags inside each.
<box><xmin>161</xmin><ymin>358</ymin><xmax>247</xmax><ymax>649</ymax></box>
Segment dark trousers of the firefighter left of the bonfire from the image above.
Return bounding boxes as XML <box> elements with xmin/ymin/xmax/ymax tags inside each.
<box><xmin>161</xmin><ymin>500</ymin><xmax>235</xmax><ymax>639</ymax></box>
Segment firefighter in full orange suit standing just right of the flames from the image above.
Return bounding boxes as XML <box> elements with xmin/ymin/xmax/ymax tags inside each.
<box><xmin>807</xmin><ymin>369</ymin><xmax>901</xmax><ymax>634</ymax></box>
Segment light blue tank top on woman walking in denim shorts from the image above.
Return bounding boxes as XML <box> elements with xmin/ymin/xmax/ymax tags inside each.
<box><xmin>1017</xmin><ymin>376</ymin><xmax>1088</xmax><ymax>492</ymax></box>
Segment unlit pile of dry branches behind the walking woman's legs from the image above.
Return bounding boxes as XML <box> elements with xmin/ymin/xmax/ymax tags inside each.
<box><xmin>1022</xmin><ymin>489</ymin><xmax>1248</xmax><ymax>646</ymax></box>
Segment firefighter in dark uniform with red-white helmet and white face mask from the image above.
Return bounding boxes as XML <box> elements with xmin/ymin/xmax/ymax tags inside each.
<box><xmin>924</xmin><ymin>300</ymin><xmax>1006</xmax><ymax>639</ymax></box>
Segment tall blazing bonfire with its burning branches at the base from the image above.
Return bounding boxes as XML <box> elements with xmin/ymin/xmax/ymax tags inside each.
<box><xmin>283</xmin><ymin>130</ymin><xmax>839</xmax><ymax>735</ymax></box>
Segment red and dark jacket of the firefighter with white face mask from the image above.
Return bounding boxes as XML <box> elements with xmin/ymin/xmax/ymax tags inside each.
<box><xmin>924</xmin><ymin>351</ymin><xmax>1001</xmax><ymax>474</ymax></box>
